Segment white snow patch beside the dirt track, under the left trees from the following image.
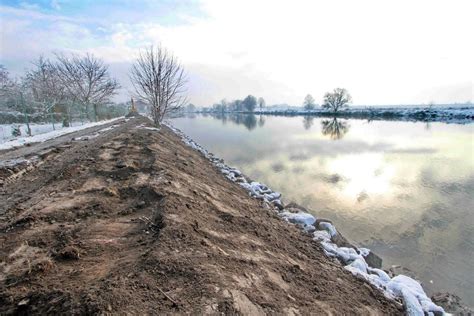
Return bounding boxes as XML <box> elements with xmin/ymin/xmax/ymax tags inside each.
<box><xmin>0</xmin><ymin>117</ymin><xmax>123</xmax><ymax>150</ymax></box>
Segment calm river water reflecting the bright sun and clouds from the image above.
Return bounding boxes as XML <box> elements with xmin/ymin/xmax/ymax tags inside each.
<box><xmin>172</xmin><ymin>115</ymin><xmax>474</xmax><ymax>306</ymax></box>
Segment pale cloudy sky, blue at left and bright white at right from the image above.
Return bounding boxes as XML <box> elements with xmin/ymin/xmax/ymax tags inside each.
<box><xmin>0</xmin><ymin>0</ymin><xmax>474</xmax><ymax>106</ymax></box>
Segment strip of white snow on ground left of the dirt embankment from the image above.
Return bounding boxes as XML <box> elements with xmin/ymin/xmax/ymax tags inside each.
<box><xmin>0</xmin><ymin>117</ymin><xmax>123</xmax><ymax>150</ymax></box>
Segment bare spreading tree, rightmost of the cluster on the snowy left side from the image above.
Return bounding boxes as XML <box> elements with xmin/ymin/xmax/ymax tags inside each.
<box><xmin>56</xmin><ymin>54</ymin><xmax>120</xmax><ymax>120</ymax></box>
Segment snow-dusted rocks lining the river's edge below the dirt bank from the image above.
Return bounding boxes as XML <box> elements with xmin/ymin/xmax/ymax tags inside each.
<box><xmin>166</xmin><ymin>124</ymin><xmax>446</xmax><ymax>316</ymax></box>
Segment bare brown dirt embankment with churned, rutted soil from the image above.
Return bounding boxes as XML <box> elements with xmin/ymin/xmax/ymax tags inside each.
<box><xmin>0</xmin><ymin>118</ymin><xmax>403</xmax><ymax>315</ymax></box>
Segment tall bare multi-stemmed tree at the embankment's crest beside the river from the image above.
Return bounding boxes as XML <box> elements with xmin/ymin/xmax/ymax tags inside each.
<box><xmin>130</xmin><ymin>45</ymin><xmax>187</xmax><ymax>124</ymax></box>
